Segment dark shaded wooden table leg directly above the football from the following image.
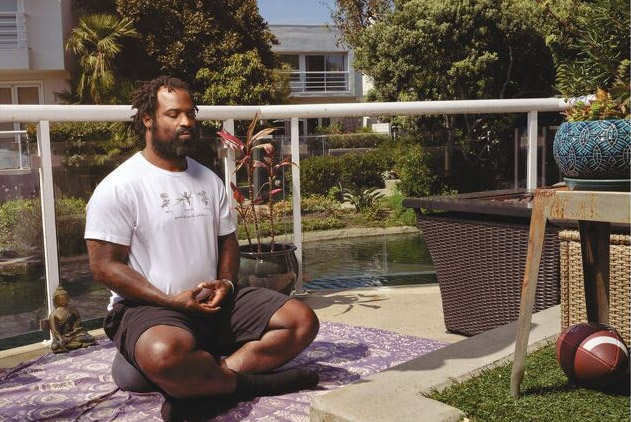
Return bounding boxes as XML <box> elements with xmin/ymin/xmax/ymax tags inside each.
<box><xmin>578</xmin><ymin>220</ymin><xmax>611</xmax><ymax>324</ymax></box>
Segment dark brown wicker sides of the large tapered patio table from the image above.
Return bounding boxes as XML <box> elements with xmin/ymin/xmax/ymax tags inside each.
<box><xmin>417</xmin><ymin>212</ymin><xmax>559</xmax><ymax>336</ymax></box>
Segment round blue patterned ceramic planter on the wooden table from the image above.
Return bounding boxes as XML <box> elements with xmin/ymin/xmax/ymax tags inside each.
<box><xmin>552</xmin><ymin>120</ymin><xmax>631</xmax><ymax>179</ymax></box>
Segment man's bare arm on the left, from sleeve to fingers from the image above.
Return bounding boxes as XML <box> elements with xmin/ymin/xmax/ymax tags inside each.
<box><xmin>86</xmin><ymin>239</ymin><xmax>219</xmax><ymax>314</ymax></box>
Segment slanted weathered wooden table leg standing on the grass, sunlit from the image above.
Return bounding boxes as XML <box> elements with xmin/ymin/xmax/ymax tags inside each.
<box><xmin>510</xmin><ymin>195</ymin><xmax>549</xmax><ymax>398</ymax></box>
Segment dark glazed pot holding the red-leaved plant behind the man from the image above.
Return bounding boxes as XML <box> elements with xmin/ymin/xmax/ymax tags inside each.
<box><xmin>239</xmin><ymin>243</ymin><xmax>298</xmax><ymax>295</ymax></box>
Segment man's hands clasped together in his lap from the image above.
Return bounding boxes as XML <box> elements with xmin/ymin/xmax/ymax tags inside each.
<box><xmin>171</xmin><ymin>280</ymin><xmax>232</xmax><ymax>315</ymax></box>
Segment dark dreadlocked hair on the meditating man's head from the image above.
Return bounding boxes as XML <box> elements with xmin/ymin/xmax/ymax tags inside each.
<box><xmin>131</xmin><ymin>75</ymin><xmax>197</xmax><ymax>137</ymax></box>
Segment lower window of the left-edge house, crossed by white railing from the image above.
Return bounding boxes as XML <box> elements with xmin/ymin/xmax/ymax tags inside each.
<box><xmin>0</xmin><ymin>83</ymin><xmax>42</xmax><ymax>170</ymax></box>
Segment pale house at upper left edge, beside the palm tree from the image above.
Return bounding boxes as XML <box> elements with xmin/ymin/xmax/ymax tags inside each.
<box><xmin>0</xmin><ymin>0</ymin><xmax>73</xmax><ymax>174</ymax></box>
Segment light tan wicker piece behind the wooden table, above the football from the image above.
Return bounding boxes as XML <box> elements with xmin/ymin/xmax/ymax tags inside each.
<box><xmin>559</xmin><ymin>230</ymin><xmax>631</xmax><ymax>345</ymax></box>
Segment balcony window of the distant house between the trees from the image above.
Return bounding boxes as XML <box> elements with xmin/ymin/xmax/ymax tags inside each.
<box><xmin>305</xmin><ymin>54</ymin><xmax>348</xmax><ymax>91</ymax></box>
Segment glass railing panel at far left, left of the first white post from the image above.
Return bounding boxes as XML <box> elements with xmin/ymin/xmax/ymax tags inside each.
<box><xmin>0</xmin><ymin>134</ymin><xmax>48</xmax><ymax>349</ymax></box>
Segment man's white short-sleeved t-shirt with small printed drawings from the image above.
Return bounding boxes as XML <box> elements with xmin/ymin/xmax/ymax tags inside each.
<box><xmin>85</xmin><ymin>153</ymin><xmax>236</xmax><ymax>310</ymax></box>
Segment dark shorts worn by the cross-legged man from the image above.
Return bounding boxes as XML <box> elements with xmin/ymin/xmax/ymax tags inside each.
<box><xmin>103</xmin><ymin>287</ymin><xmax>289</xmax><ymax>369</ymax></box>
